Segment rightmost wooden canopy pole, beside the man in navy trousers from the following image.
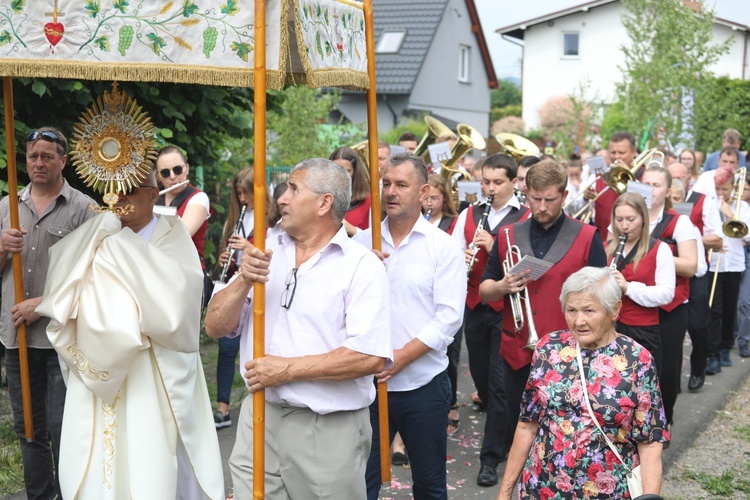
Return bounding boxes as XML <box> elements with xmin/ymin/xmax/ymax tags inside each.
<box><xmin>363</xmin><ymin>0</ymin><xmax>391</xmax><ymax>486</ymax></box>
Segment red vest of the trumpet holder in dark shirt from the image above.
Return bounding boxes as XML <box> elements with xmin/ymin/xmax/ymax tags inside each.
<box><xmin>498</xmin><ymin>217</ymin><xmax>596</xmax><ymax>371</ymax></box>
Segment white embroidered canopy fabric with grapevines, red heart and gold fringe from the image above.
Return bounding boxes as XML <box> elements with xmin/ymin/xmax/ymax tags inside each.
<box><xmin>0</xmin><ymin>0</ymin><xmax>369</xmax><ymax>89</ymax></box>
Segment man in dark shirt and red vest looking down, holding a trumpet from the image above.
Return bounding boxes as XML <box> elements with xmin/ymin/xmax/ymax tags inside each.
<box><xmin>479</xmin><ymin>160</ymin><xmax>607</xmax><ymax>454</ymax></box>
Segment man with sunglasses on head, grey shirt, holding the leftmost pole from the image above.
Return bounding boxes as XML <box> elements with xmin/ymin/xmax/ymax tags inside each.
<box><xmin>0</xmin><ymin>127</ymin><xmax>95</xmax><ymax>499</ymax></box>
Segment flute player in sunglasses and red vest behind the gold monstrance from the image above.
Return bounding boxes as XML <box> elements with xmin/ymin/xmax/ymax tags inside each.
<box><xmin>156</xmin><ymin>146</ymin><xmax>213</xmax><ymax>307</ymax></box>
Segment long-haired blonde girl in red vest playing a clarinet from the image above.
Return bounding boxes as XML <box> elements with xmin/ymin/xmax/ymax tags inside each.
<box><xmin>606</xmin><ymin>193</ymin><xmax>675</xmax><ymax>360</ymax></box>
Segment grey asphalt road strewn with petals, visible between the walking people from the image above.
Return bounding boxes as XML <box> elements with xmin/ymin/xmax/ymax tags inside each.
<box><xmin>4</xmin><ymin>342</ymin><xmax>750</xmax><ymax>500</ymax></box>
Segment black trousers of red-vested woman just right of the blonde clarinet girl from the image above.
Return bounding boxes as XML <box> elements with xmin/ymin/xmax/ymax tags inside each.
<box><xmin>659</xmin><ymin>304</ymin><xmax>687</xmax><ymax>424</ymax></box>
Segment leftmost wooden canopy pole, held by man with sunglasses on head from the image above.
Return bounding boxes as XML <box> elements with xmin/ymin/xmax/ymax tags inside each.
<box><xmin>3</xmin><ymin>78</ymin><xmax>34</xmax><ymax>442</ymax></box>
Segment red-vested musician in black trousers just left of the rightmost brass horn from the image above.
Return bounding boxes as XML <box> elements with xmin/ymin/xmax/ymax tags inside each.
<box><xmin>667</xmin><ymin>162</ymin><xmax>723</xmax><ymax>392</ymax></box>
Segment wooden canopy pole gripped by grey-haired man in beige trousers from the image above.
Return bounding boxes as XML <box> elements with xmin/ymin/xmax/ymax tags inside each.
<box><xmin>253</xmin><ymin>0</ymin><xmax>266</xmax><ymax>500</ymax></box>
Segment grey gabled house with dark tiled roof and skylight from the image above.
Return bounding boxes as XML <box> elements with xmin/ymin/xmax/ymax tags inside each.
<box><xmin>338</xmin><ymin>0</ymin><xmax>497</xmax><ymax>136</ymax></box>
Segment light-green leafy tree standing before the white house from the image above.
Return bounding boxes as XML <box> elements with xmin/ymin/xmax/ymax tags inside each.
<box><xmin>617</xmin><ymin>0</ymin><xmax>731</xmax><ymax>145</ymax></box>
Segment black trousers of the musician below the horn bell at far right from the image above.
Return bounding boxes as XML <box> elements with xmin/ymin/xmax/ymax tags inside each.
<box><xmin>709</xmin><ymin>272</ymin><xmax>742</xmax><ymax>356</ymax></box>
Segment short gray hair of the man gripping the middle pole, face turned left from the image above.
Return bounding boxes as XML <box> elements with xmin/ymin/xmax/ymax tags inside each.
<box><xmin>292</xmin><ymin>158</ymin><xmax>352</xmax><ymax>222</ymax></box>
